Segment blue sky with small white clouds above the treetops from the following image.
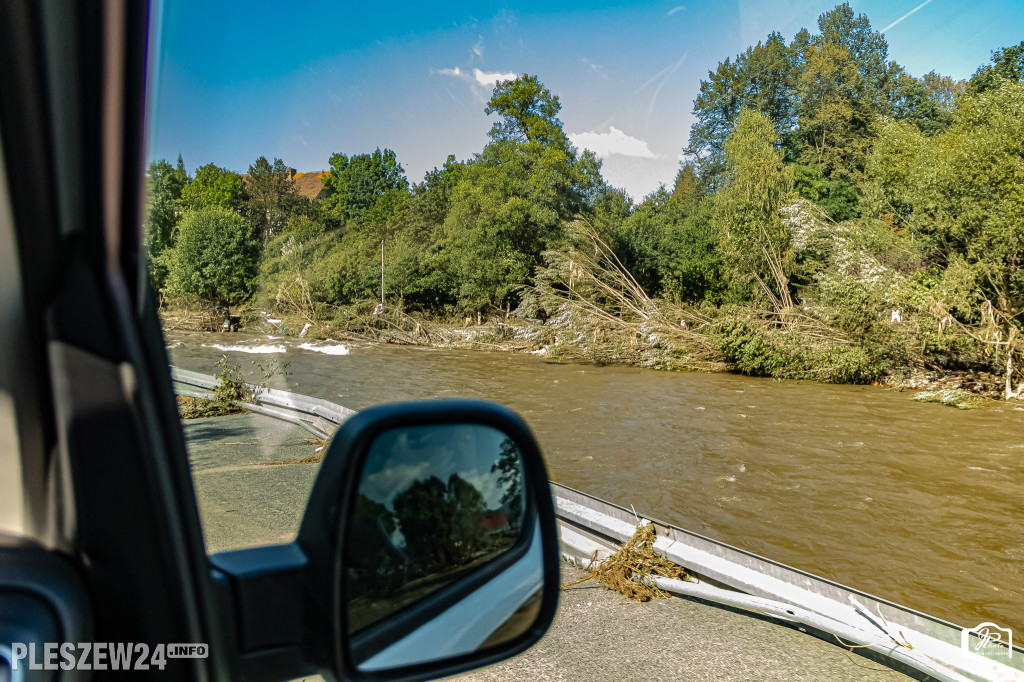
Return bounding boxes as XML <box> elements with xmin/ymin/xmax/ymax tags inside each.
<box><xmin>150</xmin><ymin>0</ymin><xmax>1024</xmax><ymax>199</ymax></box>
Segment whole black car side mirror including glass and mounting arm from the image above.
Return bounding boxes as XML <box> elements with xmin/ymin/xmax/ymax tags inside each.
<box><xmin>211</xmin><ymin>400</ymin><xmax>559</xmax><ymax>680</ymax></box>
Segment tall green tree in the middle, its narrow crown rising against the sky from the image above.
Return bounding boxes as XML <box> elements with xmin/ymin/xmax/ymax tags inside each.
<box><xmin>430</xmin><ymin>75</ymin><xmax>602</xmax><ymax>309</ymax></box>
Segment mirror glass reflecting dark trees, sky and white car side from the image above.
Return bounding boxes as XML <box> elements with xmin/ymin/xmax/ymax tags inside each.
<box><xmin>342</xmin><ymin>424</ymin><xmax>543</xmax><ymax>669</ymax></box>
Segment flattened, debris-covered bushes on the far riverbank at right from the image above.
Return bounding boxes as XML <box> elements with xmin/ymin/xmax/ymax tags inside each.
<box><xmin>516</xmin><ymin>215</ymin><xmax>1024</xmax><ymax>407</ymax></box>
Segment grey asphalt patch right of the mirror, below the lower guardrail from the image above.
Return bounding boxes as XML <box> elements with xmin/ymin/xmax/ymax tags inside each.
<box><xmin>458</xmin><ymin>565</ymin><xmax>909</xmax><ymax>682</ymax></box>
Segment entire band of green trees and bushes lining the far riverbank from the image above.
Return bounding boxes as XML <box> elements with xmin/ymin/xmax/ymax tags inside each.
<box><xmin>149</xmin><ymin>18</ymin><xmax>1024</xmax><ymax>391</ymax></box>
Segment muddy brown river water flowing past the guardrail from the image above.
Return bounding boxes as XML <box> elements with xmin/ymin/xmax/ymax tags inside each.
<box><xmin>168</xmin><ymin>333</ymin><xmax>1024</xmax><ymax>632</ymax></box>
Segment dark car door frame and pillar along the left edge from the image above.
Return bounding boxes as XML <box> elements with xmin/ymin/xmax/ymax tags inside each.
<box><xmin>0</xmin><ymin>0</ymin><xmax>228</xmax><ymax>679</ymax></box>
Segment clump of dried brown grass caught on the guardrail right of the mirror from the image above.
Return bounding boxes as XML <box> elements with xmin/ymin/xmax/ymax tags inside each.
<box><xmin>569</xmin><ymin>523</ymin><xmax>690</xmax><ymax>601</ymax></box>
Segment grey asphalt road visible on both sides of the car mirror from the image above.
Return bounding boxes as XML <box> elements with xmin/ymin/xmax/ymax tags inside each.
<box><xmin>184</xmin><ymin>415</ymin><xmax>910</xmax><ymax>682</ymax></box>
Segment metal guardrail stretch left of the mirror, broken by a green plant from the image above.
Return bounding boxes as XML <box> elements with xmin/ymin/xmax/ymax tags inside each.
<box><xmin>171</xmin><ymin>367</ymin><xmax>355</xmax><ymax>439</ymax></box>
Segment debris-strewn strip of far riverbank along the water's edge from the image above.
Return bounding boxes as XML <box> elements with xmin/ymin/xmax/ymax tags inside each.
<box><xmin>161</xmin><ymin>303</ymin><xmax>1019</xmax><ymax>409</ymax></box>
